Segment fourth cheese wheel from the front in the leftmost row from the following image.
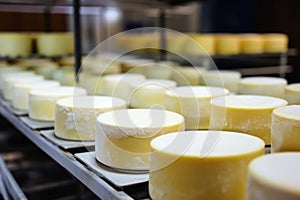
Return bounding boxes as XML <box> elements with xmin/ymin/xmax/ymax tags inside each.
<box><xmin>29</xmin><ymin>86</ymin><xmax>87</xmax><ymax>121</ymax></box>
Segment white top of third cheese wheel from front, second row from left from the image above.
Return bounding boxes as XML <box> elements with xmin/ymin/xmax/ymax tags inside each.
<box><xmin>166</xmin><ymin>86</ymin><xmax>229</xmax><ymax>98</ymax></box>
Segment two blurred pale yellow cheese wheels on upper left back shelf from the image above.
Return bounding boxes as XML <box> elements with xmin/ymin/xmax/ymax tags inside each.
<box><xmin>0</xmin><ymin>32</ymin><xmax>74</xmax><ymax>58</ymax></box>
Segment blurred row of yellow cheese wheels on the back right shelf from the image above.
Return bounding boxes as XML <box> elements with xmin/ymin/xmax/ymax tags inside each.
<box><xmin>117</xmin><ymin>32</ymin><xmax>288</xmax><ymax>55</ymax></box>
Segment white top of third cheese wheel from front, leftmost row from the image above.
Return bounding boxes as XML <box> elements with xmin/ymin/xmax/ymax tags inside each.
<box><xmin>56</xmin><ymin>96</ymin><xmax>126</xmax><ymax>109</ymax></box>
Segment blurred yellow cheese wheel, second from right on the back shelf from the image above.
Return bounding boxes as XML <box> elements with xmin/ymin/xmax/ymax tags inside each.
<box><xmin>239</xmin><ymin>34</ymin><xmax>265</xmax><ymax>54</ymax></box>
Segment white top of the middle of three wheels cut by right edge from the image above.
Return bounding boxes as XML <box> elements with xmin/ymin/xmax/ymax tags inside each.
<box><xmin>273</xmin><ymin>105</ymin><xmax>300</xmax><ymax>122</ymax></box>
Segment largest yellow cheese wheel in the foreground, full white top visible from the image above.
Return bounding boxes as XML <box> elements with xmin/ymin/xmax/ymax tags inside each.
<box><xmin>149</xmin><ymin>131</ymin><xmax>265</xmax><ymax>200</ymax></box>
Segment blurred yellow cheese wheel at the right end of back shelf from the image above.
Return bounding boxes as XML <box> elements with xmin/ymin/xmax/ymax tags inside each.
<box><xmin>263</xmin><ymin>33</ymin><xmax>288</xmax><ymax>53</ymax></box>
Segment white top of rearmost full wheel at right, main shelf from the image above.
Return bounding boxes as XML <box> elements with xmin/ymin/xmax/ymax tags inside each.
<box><xmin>240</xmin><ymin>76</ymin><xmax>287</xmax><ymax>85</ymax></box>
